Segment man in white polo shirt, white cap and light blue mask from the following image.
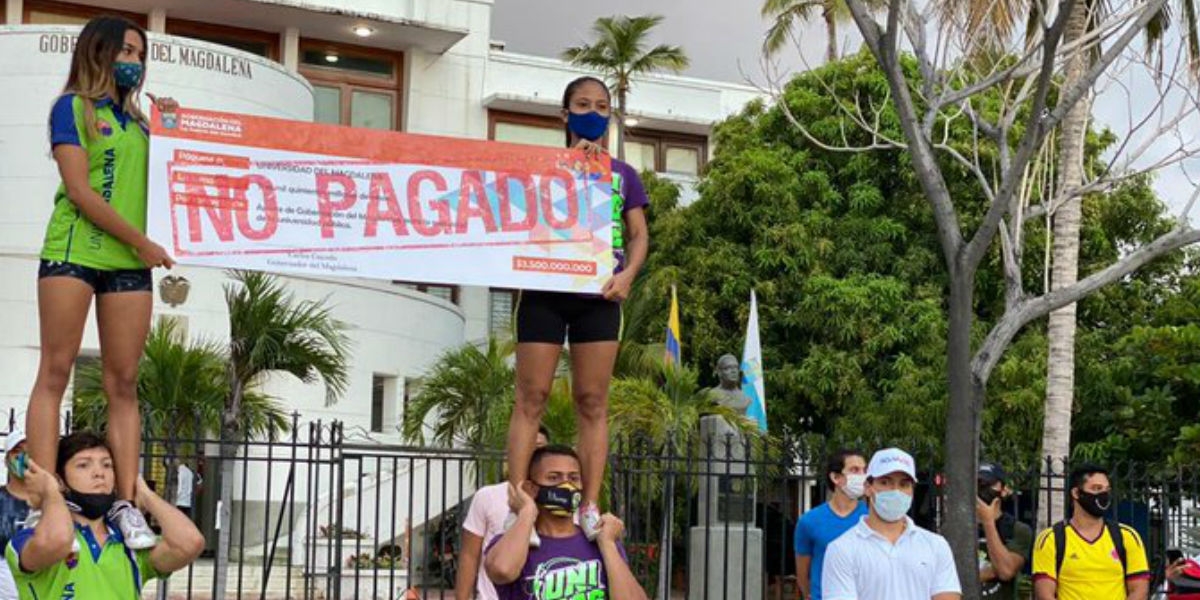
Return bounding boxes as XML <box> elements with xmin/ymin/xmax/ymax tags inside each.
<box><xmin>822</xmin><ymin>448</ymin><xmax>962</xmax><ymax>600</ymax></box>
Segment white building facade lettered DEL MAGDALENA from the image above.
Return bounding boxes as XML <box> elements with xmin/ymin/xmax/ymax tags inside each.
<box><xmin>0</xmin><ymin>0</ymin><xmax>760</xmax><ymax>580</ymax></box>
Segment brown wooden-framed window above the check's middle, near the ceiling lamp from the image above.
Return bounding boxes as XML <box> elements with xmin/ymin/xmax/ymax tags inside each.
<box><xmin>300</xmin><ymin>40</ymin><xmax>403</xmax><ymax>130</ymax></box>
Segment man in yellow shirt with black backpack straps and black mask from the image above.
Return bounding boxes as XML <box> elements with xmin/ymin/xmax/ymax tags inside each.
<box><xmin>1033</xmin><ymin>464</ymin><xmax>1150</xmax><ymax>600</ymax></box>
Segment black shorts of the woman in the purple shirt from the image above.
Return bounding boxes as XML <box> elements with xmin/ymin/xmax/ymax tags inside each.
<box><xmin>516</xmin><ymin>292</ymin><xmax>622</xmax><ymax>346</ymax></box>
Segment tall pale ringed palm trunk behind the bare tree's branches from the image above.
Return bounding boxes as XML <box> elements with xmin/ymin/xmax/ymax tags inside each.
<box><xmin>1038</xmin><ymin>2</ymin><xmax>1092</xmax><ymax>535</ymax></box>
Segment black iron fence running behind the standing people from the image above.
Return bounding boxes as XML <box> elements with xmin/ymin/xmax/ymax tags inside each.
<box><xmin>4</xmin><ymin>418</ymin><xmax>1200</xmax><ymax>600</ymax></box>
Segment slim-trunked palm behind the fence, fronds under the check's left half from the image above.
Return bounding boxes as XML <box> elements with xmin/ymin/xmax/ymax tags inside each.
<box><xmin>214</xmin><ymin>271</ymin><xmax>349</xmax><ymax>598</ymax></box>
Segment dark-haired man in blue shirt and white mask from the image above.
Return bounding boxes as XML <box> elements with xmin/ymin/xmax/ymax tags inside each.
<box><xmin>794</xmin><ymin>450</ymin><xmax>866</xmax><ymax>600</ymax></box>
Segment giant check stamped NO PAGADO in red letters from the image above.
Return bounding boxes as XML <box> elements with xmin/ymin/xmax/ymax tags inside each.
<box><xmin>148</xmin><ymin>109</ymin><xmax>614</xmax><ymax>292</ymax></box>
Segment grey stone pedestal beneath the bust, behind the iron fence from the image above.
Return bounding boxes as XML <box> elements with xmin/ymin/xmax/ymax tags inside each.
<box><xmin>688</xmin><ymin>416</ymin><xmax>764</xmax><ymax>600</ymax></box>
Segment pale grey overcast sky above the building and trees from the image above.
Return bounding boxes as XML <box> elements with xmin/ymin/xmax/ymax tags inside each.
<box><xmin>492</xmin><ymin>0</ymin><xmax>1200</xmax><ymax>222</ymax></box>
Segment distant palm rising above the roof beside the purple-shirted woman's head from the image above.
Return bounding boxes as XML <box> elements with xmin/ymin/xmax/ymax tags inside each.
<box><xmin>563</xmin><ymin>14</ymin><xmax>689</xmax><ymax>161</ymax></box>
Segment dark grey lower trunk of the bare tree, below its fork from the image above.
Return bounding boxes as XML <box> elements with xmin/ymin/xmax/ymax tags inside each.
<box><xmin>942</xmin><ymin>271</ymin><xmax>983</xmax><ymax>600</ymax></box>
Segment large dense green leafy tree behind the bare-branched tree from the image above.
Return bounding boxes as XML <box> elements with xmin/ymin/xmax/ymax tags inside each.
<box><xmin>643</xmin><ymin>49</ymin><xmax>1180</xmax><ymax>469</ymax></box>
